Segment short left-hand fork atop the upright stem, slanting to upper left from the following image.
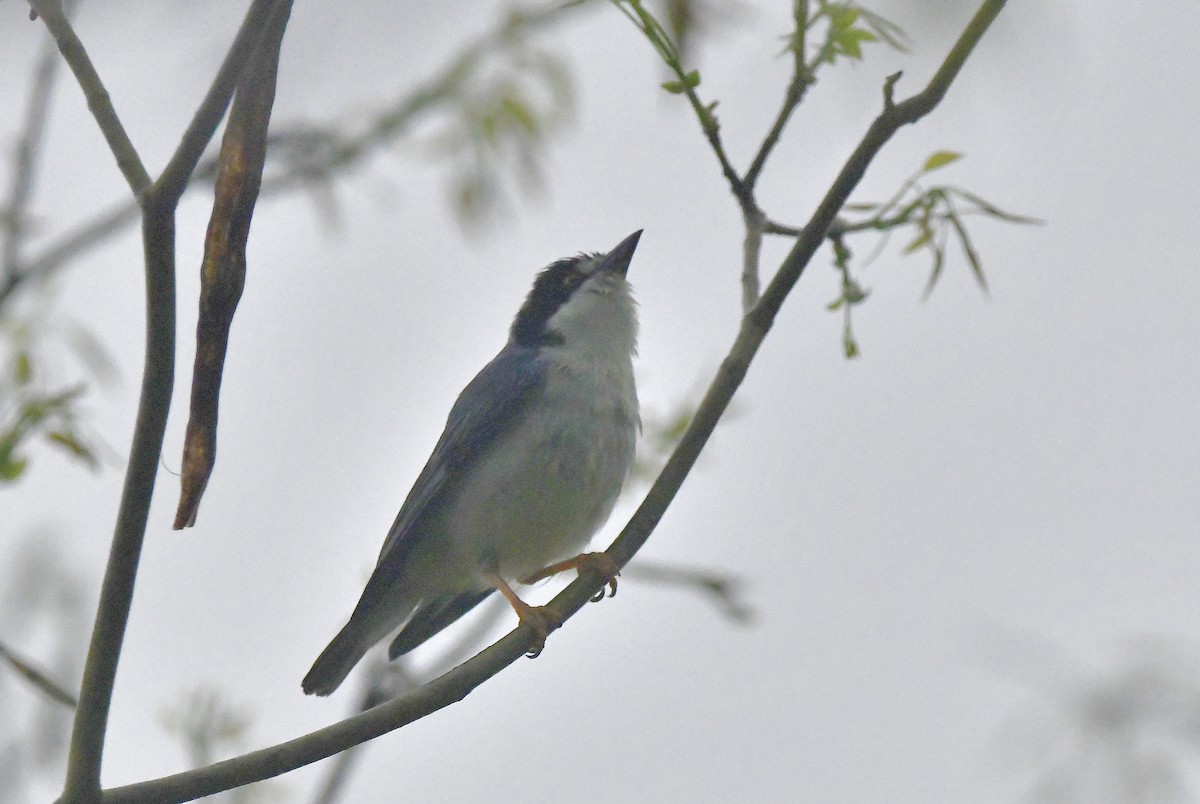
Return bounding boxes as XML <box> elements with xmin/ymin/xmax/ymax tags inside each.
<box><xmin>29</xmin><ymin>0</ymin><xmax>150</xmax><ymax>197</ymax></box>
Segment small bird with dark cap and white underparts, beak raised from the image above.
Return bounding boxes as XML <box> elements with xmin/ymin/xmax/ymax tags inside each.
<box><xmin>301</xmin><ymin>229</ymin><xmax>642</xmax><ymax>696</ymax></box>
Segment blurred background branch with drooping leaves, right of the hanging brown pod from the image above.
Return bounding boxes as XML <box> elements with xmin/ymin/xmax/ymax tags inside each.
<box><xmin>217</xmin><ymin>0</ymin><xmax>587</xmax><ymax>230</ymax></box>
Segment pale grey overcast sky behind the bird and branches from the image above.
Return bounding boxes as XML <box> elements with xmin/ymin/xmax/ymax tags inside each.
<box><xmin>0</xmin><ymin>0</ymin><xmax>1200</xmax><ymax>803</ymax></box>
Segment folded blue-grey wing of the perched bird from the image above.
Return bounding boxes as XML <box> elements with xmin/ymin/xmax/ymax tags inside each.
<box><xmin>364</xmin><ymin>343</ymin><xmax>546</xmax><ymax>585</ymax></box>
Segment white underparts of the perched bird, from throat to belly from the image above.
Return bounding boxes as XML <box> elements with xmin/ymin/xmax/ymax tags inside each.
<box><xmin>446</xmin><ymin>271</ymin><xmax>640</xmax><ymax>588</ymax></box>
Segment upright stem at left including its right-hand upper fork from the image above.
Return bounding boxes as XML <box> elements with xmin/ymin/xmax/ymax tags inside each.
<box><xmin>60</xmin><ymin>0</ymin><xmax>290</xmax><ymax>803</ymax></box>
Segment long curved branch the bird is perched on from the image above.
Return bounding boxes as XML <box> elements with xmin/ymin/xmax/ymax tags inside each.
<box><xmin>91</xmin><ymin>0</ymin><xmax>1004</xmax><ymax>804</ymax></box>
